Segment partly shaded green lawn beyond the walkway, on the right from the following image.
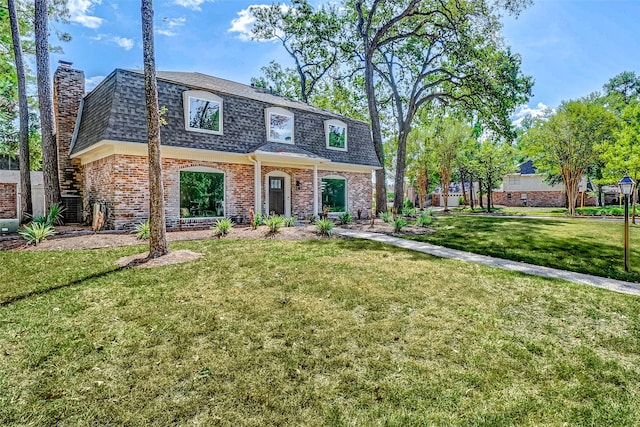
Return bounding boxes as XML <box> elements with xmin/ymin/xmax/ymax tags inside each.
<box><xmin>409</xmin><ymin>216</ymin><xmax>640</xmax><ymax>282</ymax></box>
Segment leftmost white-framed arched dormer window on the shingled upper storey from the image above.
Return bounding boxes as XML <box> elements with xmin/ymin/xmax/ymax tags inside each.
<box><xmin>182</xmin><ymin>90</ymin><xmax>222</xmax><ymax>135</ymax></box>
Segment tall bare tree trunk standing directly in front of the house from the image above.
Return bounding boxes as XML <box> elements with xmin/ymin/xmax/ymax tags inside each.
<box><xmin>141</xmin><ymin>0</ymin><xmax>169</xmax><ymax>259</ymax></box>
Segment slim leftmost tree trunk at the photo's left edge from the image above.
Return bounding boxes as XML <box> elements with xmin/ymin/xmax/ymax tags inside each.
<box><xmin>7</xmin><ymin>0</ymin><xmax>33</xmax><ymax>223</ymax></box>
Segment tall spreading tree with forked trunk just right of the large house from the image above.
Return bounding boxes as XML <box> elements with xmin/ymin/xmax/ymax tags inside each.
<box><xmin>347</xmin><ymin>0</ymin><xmax>532</xmax><ymax>213</ymax></box>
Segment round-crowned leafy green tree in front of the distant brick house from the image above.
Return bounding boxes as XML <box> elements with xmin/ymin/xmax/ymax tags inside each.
<box><xmin>523</xmin><ymin>100</ymin><xmax>618</xmax><ymax>215</ymax></box>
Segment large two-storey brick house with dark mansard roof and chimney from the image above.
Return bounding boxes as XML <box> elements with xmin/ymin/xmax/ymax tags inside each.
<box><xmin>54</xmin><ymin>63</ymin><xmax>380</xmax><ymax>229</ymax></box>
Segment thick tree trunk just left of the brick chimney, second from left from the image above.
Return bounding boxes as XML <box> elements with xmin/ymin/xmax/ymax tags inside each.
<box><xmin>34</xmin><ymin>0</ymin><xmax>60</xmax><ymax>211</ymax></box>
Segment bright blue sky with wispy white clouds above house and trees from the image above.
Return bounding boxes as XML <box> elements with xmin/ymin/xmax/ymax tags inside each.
<box><xmin>51</xmin><ymin>0</ymin><xmax>640</xmax><ymax>120</ymax></box>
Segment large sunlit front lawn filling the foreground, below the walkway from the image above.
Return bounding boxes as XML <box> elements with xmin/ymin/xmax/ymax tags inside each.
<box><xmin>0</xmin><ymin>239</ymin><xmax>640</xmax><ymax>426</ymax></box>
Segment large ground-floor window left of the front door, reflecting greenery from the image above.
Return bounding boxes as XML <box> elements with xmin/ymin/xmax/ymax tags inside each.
<box><xmin>180</xmin><ymin>171</ymin><xmax>224</xmax><ymax>218</ymax></box>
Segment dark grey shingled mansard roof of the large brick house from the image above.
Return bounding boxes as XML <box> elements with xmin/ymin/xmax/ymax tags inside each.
<box><xmin>72</xmin><ymin>69</ymin><xmax>380</xmax><ymax>167</ymax></box>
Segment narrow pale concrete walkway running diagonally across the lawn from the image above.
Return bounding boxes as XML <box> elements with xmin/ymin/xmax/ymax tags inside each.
<box><xmin>333</xmin><ymin>228</ymin><xmax>640</xmax><ymax>296</ymax></box>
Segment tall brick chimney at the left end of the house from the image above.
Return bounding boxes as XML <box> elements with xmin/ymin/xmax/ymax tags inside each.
<box><xmin>53</xmin><ymin>61</ymin><xmax>84</xmax><ymax>222</ymax></box>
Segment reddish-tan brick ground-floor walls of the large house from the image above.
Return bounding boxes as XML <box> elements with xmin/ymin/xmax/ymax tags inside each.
<box><xmin>83</xmin><ymin>155</ymin><xmax>373</xmax><ymax>230</ymax></box>
